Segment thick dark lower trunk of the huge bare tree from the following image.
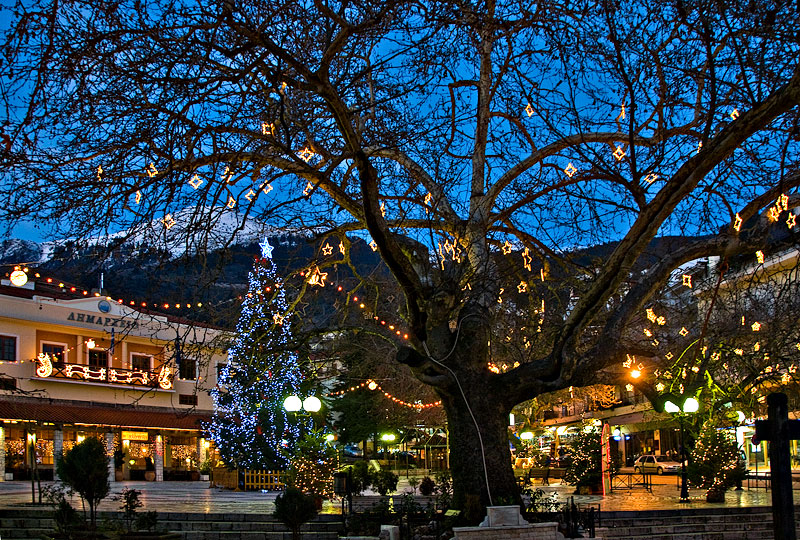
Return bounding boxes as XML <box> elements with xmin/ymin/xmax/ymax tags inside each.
<box><xmin>442</xmin><ymin>382</ymin><xmax>520</xmax><ymax>508</ymax></box>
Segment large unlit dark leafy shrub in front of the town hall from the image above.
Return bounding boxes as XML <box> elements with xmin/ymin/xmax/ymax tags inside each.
<box><xmin>56</xmin><ymin>437</ymin><xmax>111</xmax><ymax>528</ymax></box>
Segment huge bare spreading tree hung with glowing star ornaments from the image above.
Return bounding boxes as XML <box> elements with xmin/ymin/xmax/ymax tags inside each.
<box><xmin>0</xmin><ymin>0</ymin><xmax>800</xmax><ymax>504</ymax></box>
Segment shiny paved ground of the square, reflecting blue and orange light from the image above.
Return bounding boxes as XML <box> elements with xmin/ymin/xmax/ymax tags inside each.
<box><xmin>0</xmin><ymin>477</ymin><xmax>780</xmax><ymax>514</ymax></box>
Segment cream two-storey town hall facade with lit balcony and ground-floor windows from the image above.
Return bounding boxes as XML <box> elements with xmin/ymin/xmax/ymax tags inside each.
<box><xmin>0</xmin><ymin>276</ymin><xmax>228</xmax><ymax>481</ymax></box>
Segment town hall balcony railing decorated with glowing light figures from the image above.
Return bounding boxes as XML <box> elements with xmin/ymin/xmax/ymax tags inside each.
<box><xmin>36</xmin><ymin>353</ymin><xmax>174</xmax><ymax>390</ymax></box>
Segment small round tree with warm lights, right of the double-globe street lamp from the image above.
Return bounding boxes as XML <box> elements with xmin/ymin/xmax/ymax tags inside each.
<box><xmin>688</xmin><ymin>423</ymin><xmax>747</xmax><ymax>502</ymax></box>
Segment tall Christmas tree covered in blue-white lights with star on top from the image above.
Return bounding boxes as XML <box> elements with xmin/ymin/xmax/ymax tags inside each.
<box><xmin>208</xmin><ymin>239</ymin><xmax>308</xmax><ymax>469</ymax></box>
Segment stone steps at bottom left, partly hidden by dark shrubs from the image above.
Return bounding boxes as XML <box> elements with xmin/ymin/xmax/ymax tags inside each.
<box><xmin>0</xmin><ymin>508</ymin><xmax>342</xmax><ymax>540</ymax></box>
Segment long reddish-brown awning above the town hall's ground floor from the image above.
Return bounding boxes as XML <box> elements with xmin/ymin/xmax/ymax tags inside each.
<box><xmin>0</xmin><ymin>398</ymin><xmax>211</xmax><ymax>430</ymax></box>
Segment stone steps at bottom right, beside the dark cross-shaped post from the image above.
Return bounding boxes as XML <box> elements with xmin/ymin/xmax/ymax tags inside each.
<box><xmin>595</xmin><ymin>507</ymin><xmax>800</xmax><ymax>540</ymax></box>
